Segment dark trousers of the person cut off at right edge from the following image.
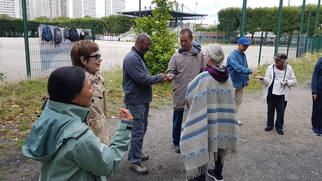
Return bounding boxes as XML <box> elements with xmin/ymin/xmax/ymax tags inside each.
<box><xmin>311</xmin><ymin>90</ymin><xmax>322</xmax><ymax>129</ymax></box>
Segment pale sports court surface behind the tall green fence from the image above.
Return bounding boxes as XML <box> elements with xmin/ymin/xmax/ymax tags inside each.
<box><xmin>0</xmin><ymin>37</ymin><xmax>296</xmax><ymax>80</ymax></box>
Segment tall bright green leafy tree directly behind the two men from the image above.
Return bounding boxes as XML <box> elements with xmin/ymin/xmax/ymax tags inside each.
<box><xmin>134</xmin><ymin>0</ymin><xmax>178</xmax><ymax>75</ymax></box>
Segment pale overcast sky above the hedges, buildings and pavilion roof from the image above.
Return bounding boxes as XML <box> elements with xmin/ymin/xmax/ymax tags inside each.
<box><xmin>97</xmin><ymin>0</ymin><xmax>319</xmax><ymax>24</ymax></box>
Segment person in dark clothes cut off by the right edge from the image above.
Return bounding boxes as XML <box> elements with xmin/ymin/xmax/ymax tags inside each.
<box><xmin>311</xmin><ymin>57</ymin><xmax>322</xmax><ymax>136</ymax></box>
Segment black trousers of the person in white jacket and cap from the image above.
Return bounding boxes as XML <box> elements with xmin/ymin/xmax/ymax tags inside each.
<box><xmin>266</xmin><ymin>94</ymin><xmax>287</xmax><ymax>129</ymax></box>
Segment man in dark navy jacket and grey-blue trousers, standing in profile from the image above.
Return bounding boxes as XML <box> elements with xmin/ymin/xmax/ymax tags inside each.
<box><xmin>123</xmin><ymin>33</ymin><xmax>170</xmax><ymax>175</ymax></box>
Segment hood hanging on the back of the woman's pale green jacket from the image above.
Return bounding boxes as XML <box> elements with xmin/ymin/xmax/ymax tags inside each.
<box><xmin>22</xmin><ymin>100</ymin><xmax>90</xmax><ymax>162</ymax></box>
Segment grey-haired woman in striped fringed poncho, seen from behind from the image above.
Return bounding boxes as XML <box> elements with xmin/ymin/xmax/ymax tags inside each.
<box><xmin>180</xmin><ymin>44</ymin><xmax>238</xmax><ymax>181</ymax></box>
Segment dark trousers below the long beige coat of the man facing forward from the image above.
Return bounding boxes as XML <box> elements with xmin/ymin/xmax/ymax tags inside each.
<box><xmin>172</xmin><ymin>110</ymin><xmax>183</xmax><ymax>145</ymax></box>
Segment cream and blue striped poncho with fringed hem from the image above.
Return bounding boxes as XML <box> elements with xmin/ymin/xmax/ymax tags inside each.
<box><xmin>180</xmin><ymin>72</ymin><xmax>238</xmax><ymax>176</ymax></box>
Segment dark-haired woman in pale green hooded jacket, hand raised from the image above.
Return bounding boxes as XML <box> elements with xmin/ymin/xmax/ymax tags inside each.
<box><xmin>22</xmin><ymin>67</ymin><xmax>133</xmax><ymax>181</ymax></box>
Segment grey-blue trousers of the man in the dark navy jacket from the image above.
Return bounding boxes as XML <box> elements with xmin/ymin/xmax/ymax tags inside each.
<box><xmin>126</xmin><ymin>103</ymin><xmax>149</xmax><ymax>163</ymax></box>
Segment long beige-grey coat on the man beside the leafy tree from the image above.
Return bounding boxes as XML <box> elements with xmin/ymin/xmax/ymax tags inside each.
<box><xmin>167</xmin><ymin>45</ymin><xmax>205</xmax><ymax>111</ymax></box>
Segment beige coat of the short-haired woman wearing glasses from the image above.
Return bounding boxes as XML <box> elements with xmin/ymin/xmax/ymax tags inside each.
<box><xmin>86</xmin><ymin>72</ymin><xmax>110</xmax><ymax>146</ymax></box>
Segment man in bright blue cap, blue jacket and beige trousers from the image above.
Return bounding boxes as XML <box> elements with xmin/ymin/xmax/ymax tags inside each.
<box><xmin>226</xmin><ymin>37</ymin><xmax>260</xmax><ymax>124</ymax></box>
